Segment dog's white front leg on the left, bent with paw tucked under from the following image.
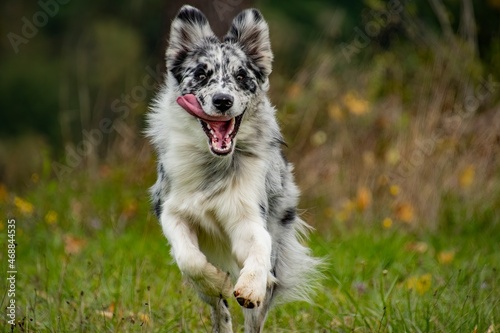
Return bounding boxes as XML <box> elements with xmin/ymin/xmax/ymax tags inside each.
<box><xmin>161</xmin><ymin>210</ymin><xmax>232</xmax><ymax>298</ymax></box>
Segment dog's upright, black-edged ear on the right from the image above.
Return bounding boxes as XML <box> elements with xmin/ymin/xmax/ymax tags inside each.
<box><xmin>224</xmin><ymin>8</ymin><xmax>273</xmax><ymax>82</ymax></box>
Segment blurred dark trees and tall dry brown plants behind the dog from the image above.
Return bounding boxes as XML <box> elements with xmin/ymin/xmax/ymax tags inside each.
<box><xmin>0</xmin><ymin>0</ymin><xmax>500</xmax><ymax>227</ymax></box>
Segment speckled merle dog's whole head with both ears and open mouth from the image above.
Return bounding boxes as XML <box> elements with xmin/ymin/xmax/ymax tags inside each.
<box><xmin>166</xmin><ymin>5</ymin><xmax>273</xmax><ymax>156</ymax></box>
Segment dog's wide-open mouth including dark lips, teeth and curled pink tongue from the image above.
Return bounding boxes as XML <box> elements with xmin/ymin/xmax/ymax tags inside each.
<box><xmin>177</xmin><ymin>94</ymin><xmax>243</xmax><ymax>155</ymax></box>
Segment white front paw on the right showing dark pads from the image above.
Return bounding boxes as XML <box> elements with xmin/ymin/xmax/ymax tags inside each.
<box><xmin>233</xmin><ymin>272</ymin><xmax>267</xmax><ymax>309</ymax></box>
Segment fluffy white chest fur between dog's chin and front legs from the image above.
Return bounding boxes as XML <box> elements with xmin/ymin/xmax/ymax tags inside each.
<box><xmin>163</xmin><ymin>147</ymin><xmax>266</xmax><ymax>277</ymax></box>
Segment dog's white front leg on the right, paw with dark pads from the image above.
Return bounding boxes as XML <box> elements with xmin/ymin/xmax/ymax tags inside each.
<box><xmin>231</xmin><ymin>219</ymin><xmax>275</xmax><ymax>309</ymax></box>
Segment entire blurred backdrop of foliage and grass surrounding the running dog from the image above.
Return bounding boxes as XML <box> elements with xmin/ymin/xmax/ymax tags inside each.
<box><xmin>0</xmin><ymin>0</ymin><xmax>500</xmax><ymax>333</ymax></box>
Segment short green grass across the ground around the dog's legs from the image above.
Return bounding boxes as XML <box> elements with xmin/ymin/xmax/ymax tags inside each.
<box><xmin>0</xmin><ymin>167</ymin><xmax>500</xmax><ymax>333</ymax></box>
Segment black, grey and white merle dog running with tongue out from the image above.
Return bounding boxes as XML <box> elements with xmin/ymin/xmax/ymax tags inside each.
<box><xmin>146</xmin><ymin>5</ymin><xmax>321</xmax><ymax>333</ymax></box>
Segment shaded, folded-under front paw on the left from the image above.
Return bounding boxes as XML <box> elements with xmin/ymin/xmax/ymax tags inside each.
<box><xmin>189</xmin><ymin>263</ymin><xmax>233</xmax><ymax>299</ymax></box>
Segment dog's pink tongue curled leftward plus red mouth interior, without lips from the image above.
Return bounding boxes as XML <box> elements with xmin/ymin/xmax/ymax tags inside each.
<box><xmin>177</xmin><ymin>94</ymin><xmax>234</xmax><ymax>151</ymax></box>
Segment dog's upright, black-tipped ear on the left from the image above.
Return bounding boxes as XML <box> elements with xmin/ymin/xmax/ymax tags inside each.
<box><xmin>166</xmin><ymin>5</ymin><xmax>218</xmax><ymax>82</ymax></box>
